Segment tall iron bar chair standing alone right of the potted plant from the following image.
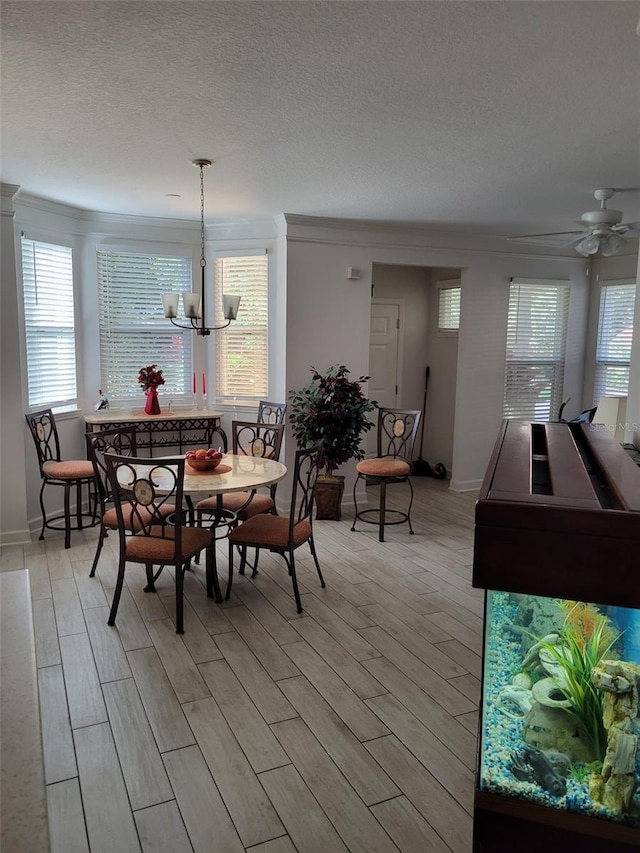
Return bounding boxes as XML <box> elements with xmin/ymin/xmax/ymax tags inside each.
<box><xmin>351</xmin><ymin>409</ymin><xmax>421</xmax><ymax>542</ymax></box>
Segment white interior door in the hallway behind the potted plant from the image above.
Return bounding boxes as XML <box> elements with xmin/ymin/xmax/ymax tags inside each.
<box><xmin>367</xmin><ymin>301</ymin><xmax>400</xmax><ymax>453</ymax></box>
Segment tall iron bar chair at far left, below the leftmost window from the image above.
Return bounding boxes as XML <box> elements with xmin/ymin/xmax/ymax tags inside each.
<box><xmin>25</xmin><ymin>409</ymin><xmax>97</xmax><ymax>548</ymax></box>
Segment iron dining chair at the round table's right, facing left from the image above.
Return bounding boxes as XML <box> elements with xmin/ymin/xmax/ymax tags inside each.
<box><xmin>226</xmin><ymin>446</ymin><xmax>325</xmax><ymax>613</ymax></box>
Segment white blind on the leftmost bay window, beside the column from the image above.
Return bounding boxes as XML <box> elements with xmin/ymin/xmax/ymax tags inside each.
<box><xmin>22</xmin><ymin>238</ymin><xmax>77</xmax><ymax>408</ymax></box>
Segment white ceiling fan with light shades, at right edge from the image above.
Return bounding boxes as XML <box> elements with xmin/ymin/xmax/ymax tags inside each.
<box><xmin>507</xmin><ymin>188</ymin><xmax>640</xmax><ymax>258</ymax></box>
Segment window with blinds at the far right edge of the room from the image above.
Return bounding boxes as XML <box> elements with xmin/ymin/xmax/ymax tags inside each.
<box><xmin>593</xmin><ymin>281</ymin><xmax>636</xmax><ymax>405</ymax></box>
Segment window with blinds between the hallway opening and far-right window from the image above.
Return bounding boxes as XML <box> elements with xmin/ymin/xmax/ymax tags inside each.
<box><xmin>504</xmin><ymin>279</ymin><xmax>569</xmax><ymax>421</ymax></box>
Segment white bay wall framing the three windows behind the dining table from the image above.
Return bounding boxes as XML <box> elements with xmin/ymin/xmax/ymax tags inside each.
<box><xmin>0</xmin><ymin>193</ymin><xmax>286</xmax><ymax>544</ymax></box>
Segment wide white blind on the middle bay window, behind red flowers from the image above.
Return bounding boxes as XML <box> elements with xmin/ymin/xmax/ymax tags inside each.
<box><xmin>94</xmin><ymin>251</ymin><xmax>194</xmax><ymax>397</ymax></box>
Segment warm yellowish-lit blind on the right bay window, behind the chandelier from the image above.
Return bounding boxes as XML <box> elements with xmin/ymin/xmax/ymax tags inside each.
<box><xmin>215</xmin><ymin>254</ymin><xmax>269</xmax><ymax>400</ymax></box>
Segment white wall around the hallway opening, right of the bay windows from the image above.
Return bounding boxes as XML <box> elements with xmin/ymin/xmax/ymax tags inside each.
<box><xmin>287</xmin><ymin>217</ymin><xmax>588</xmax><ymax>489</ymax></box>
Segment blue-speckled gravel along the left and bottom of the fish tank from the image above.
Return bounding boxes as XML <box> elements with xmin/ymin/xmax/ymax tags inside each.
<box><xmin>480</xmin><ymin>592</ymin><xmax>640</xmax><ymax>825</ymax></box>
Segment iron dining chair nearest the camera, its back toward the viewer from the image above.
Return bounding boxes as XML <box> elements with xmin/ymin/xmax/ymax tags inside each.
<box><xmin>105</xmin><ymin>454</ymin><xmax>222</xmax><ymax>634</ymax></box>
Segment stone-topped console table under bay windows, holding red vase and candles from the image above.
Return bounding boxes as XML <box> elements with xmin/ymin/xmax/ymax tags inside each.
<box><xmin>83</xmin><ymin>409</ymin><xmax>227</xmax><ymax>456</ymax></box>
